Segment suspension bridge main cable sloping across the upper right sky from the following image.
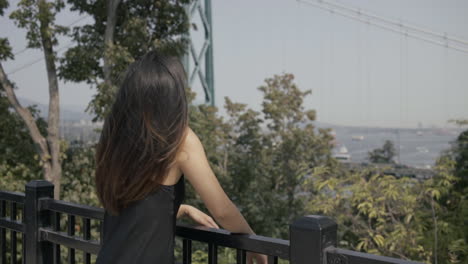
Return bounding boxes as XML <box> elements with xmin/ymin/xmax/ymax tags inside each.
<box><xmin>297</xmin><ymin>0</ymin><xmax>468</xmax><ymax>53</ymax></box>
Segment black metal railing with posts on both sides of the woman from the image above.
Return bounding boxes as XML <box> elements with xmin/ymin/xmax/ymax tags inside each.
<box><xmin>0</xmin><ymin>180</ymin><xmax>424</xmax><ymax>264</ymax></box>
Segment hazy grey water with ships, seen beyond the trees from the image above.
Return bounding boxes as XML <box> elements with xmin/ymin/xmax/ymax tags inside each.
<box><xmin>20</xmin><ymin>98</ymin><xmax>463</xmax><ymax>169</ymax></box>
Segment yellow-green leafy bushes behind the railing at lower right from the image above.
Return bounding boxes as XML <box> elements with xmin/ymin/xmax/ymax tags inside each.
<box><xmin>306</xmin><ymin>152</ymin><xmax>468</xmax><ymax>263</ymax></box>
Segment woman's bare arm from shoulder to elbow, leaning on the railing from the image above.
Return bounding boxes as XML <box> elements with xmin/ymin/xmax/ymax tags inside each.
<box><xmin>178</xmin><ymin>128</ymin><xmax>255</xmax><ymax>234</ymax></box>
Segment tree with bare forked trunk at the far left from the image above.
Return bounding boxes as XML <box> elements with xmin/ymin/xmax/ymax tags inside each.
<box><xmin>0</xmin><ymin>0</ymin><xmax>67</xmax><ymax>199</ymax></box>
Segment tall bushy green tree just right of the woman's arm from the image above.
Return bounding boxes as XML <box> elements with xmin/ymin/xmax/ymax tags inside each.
<box><xmin>185</xmin><ymin>74</ymin><xmax>336</xmax><ymax>238</ymax></box>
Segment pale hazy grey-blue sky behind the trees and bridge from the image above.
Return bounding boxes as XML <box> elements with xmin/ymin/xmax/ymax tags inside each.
<box><xmin>0</xmin><ymin>0</ymin><xmax>468</xmax><ymax>127</ymax></box>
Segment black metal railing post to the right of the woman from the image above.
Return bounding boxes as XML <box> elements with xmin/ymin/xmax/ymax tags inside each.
<box><xmin>289</xmin><ymin>215</ymin><xmax>337</xmax><ymax>264</ymax></box>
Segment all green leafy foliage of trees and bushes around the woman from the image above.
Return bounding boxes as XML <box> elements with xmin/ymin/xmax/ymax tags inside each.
<box><xmin>0</xmin><ymin>0</ymin><xmax>468</xmax><ymax>258</ymax></box>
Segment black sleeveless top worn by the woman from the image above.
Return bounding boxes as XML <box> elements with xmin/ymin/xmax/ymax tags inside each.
<box><xmin>96</xmin><ymin>175</ymin><xmax>185</xmax><ymax>264</ymax></box>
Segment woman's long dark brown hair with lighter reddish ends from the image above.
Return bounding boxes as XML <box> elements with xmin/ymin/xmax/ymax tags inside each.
<box><xmin>95</xmin><ymin>51</ymin><xmax>188</xmax><ymax>215</ymax></box>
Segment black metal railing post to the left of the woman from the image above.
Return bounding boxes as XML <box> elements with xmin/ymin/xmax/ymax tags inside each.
<box><xmin>24</xmin><ymin>180</ymin><xmax>54</xmax><ymax>264</ymax></box>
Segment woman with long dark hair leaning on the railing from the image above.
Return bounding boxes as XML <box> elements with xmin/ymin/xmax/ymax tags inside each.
<box><xmin>96</xmin><ymin>51</ymin><xmax>266</xmax><ymax>264</ymax></box>
